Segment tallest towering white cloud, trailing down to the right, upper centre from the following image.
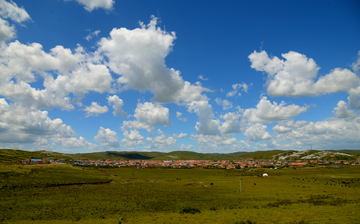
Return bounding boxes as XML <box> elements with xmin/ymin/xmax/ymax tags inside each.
<box><xmin>99</xmin><ymin>17</ymin><xmax>209</xmax><ymax>103</ymax></box>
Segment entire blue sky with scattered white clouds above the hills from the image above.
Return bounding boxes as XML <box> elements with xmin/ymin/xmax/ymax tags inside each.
<box><xmin>0</xmin><ymin>0</ymin><xmax>360</xmax><ymax>153</ymax></box>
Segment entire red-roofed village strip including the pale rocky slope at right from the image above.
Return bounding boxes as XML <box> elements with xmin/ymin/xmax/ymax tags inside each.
<box><xmin>22</xmin><ymin>151</ymin><xmax>360</xmax><ymax>169</ymax></box>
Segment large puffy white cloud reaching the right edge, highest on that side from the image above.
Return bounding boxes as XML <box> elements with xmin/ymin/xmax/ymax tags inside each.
<box><xmin>249</xmin><ymin>51</ymin><xmax>360</xmax><ymax>97</ymax></box>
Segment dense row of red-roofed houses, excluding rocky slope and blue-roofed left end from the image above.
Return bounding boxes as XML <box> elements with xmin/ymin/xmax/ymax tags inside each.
<box><xmin>73</xmin><ymin>158</ymin><xmax>359</xmax><ymax>169</ymax></box>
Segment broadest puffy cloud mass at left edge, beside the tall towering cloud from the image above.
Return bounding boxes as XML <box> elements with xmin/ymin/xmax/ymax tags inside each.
<box><xmin>0</xmin><ymin>41</ymin><xmax>113</xmax><ymax>110</ymax></box>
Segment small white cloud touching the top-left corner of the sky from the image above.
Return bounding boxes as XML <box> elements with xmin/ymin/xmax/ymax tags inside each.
<box><xmin>0</xmin><ymin>0</ymin><xmax>30</xmax><ymax>23</ymax></box>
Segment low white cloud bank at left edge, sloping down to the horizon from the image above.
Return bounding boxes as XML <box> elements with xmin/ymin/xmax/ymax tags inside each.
<box><xmin>0</xmin><ymin>98</ymin><xmax>97</xmax><ymax>150</ymax></box>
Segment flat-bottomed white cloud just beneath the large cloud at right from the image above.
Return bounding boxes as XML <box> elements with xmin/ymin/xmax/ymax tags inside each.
<box><xmin>243</xmin><ymin>96</ymin><xmax>308</xmax><ymax>123</ymax></box>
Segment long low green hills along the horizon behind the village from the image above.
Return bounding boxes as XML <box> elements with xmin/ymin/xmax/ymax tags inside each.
<box><xmin>0</xmin><ymin>149</ymin><xmax>360</xmax><ymax>164</ymax></box>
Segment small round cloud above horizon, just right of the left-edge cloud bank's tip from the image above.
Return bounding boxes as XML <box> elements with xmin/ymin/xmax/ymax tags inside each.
<box><xmin>94</xmin><ymin>127</ymin><xmax>120</xmax><ymax>149</ymax></box>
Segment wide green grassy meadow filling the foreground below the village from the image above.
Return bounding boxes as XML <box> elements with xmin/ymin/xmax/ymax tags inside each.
<box><xmin>0</xmin><ymin>164</ymin><xmax>360</xmax><ymax>224</ymax></box>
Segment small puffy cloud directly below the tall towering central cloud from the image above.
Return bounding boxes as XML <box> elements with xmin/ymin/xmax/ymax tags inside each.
<box><xmin>122</xmin><ymin>102</ymin><xmax>171</xmax><ymax>131</ymax></box>
